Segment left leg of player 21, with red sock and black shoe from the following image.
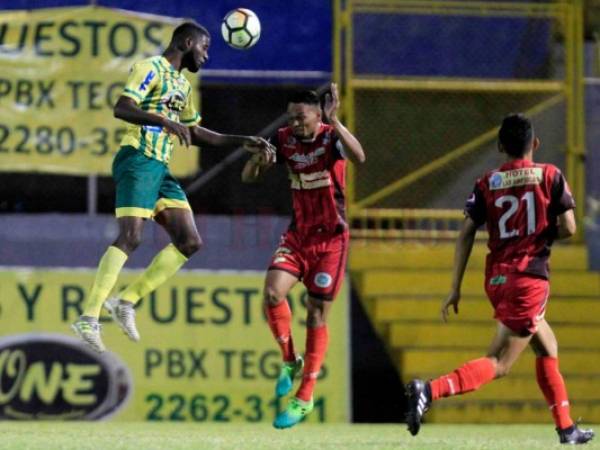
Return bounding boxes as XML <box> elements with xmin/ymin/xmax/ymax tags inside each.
<box><xmin>406</xmin><ymin>322</ymin><xmax>531</xmax><ymax>436</ymax></box>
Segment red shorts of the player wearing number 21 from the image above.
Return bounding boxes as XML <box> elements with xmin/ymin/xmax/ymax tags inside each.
<box><xmin>485</xmin><ymin>271</ymin><xmax>550</xmax><ymax>336</ymax></box>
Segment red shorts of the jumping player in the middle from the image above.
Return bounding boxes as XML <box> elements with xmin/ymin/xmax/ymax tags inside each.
<box><xmin>269</xmin><ymin>230</ymin><xmax>350</xmax><ymax>300</ymax></box>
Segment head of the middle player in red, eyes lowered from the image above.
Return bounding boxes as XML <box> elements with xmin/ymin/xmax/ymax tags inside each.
<box><xmin>287</xmin><ymin>91</ymin><xmax>321</xmax><ymax>139</ymax></box>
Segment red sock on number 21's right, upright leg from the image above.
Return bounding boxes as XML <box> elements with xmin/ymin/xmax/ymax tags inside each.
<box><xmin>535</xmin><ymin>356</ymin><xmax>573</xmax><ymax>430</ymax></box>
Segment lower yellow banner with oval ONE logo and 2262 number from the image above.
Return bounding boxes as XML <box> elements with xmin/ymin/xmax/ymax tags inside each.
<box><xmin>0</xmin><ymin>269</ymin><xmax>350</xmax><ymax>422</ymax></box>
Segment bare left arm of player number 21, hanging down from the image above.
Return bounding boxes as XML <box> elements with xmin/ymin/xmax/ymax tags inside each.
<box><xmin>440</xmin><ymin>217</ymin><xmax>477</xmax><ymax>322</ymax></box>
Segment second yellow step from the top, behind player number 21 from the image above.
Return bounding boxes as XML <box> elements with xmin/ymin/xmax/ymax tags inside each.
<box><xmin>353</xmin><ymin>269</ymin><xmax>600</xmax><ymax>299</ymax></box>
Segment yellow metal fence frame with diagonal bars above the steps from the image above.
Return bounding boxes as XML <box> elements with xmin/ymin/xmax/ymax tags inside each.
<box><xmin>333</xmin><ymin>0</ymin><xmax>585</xmax><ymax>238</ymax></box>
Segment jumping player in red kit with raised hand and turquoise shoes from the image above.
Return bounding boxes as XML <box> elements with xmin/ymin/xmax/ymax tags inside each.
<box><xmin>242</xmin><ymin>84</ymin><xmax>365</xmax><ymax>428</ymax></box>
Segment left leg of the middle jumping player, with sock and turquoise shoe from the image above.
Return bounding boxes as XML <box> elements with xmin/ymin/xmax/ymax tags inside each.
<box><xmin>263</xmin><ymin>270</ymin><xmax>303</xmax><ymax>397</ymax></box>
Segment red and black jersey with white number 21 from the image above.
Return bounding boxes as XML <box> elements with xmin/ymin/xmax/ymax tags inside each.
<box><xmin>465</xmin><ymin>159</ymin><xmax>575</xmax><ymax>278</ymax></box>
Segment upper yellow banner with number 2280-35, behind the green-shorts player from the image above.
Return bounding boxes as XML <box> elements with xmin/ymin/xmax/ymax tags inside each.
<box><xmin>0</xmin><ymin>6</ymin><xmax>199</xmax><ymax>176</ymax></box>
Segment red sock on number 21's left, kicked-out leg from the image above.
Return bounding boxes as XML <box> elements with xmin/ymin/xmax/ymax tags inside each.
<box><xmin>431</xmin><ymin>358</ymin><xmax>496</xmax><ymax>400</ymax></box>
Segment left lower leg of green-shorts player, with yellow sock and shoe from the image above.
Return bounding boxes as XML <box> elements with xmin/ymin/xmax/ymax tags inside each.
<box><xmin>71</xmin><ymin>217</ymin><xmax>144</xmax><ymax>352</ymax></box>
